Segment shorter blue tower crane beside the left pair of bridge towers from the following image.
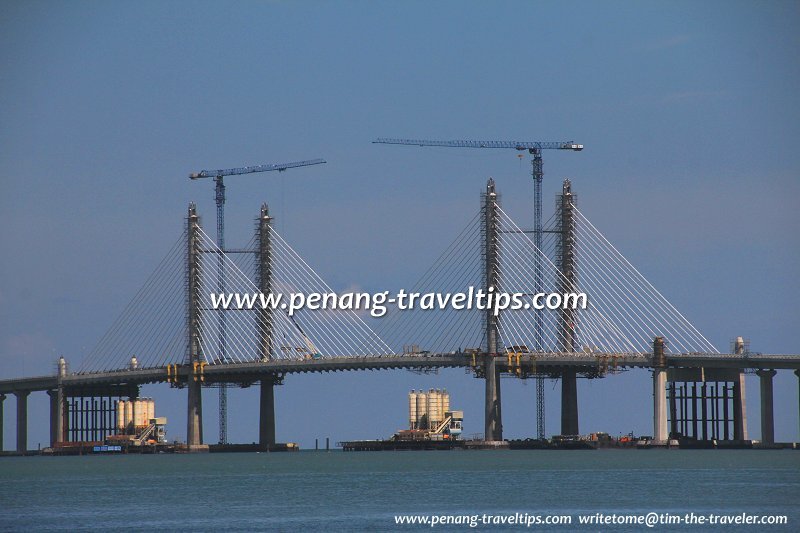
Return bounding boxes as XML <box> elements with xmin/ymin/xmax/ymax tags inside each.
<box><xmin>189</xmin><ymin>159</ymin><xmax>326</xmax><ymax>444</ymax></box>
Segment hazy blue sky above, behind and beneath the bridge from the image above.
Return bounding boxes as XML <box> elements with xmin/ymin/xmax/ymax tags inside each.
<box><xmin>0</xmin><ymin>1</ymin><xmax>800</xmax><ymax>449</ymax></box>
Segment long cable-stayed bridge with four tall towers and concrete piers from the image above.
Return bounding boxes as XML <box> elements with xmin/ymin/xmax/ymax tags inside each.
<box><xmin>0</xmin><ymin>180</ymin><xmax>800</xmax><ymax>451</ymax></box>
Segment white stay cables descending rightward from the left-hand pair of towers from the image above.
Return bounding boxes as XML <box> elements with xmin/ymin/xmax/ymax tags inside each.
<box><xmin>194</xmin><ymin>224</ymin><xmax>392</xmax><ymax>364</ymax></box>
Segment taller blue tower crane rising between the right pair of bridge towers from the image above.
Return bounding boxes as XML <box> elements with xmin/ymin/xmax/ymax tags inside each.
<box><xmin>372</xmin><ymin>137</ymin><xmax>583</xmax><ymax>439</ymax></box>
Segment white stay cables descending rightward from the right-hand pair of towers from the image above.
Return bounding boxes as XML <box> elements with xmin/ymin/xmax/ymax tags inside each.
<box><xmin>490</xmin><ymin>205</ymin><xmax>717</xmax><ymax>354</ymax></box>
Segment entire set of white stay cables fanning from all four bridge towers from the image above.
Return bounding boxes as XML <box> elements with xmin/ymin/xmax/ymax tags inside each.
<box><xmin>78</xmin><ymin>195</ymin><xmax>719</xmax><ymax>373</ymax></box>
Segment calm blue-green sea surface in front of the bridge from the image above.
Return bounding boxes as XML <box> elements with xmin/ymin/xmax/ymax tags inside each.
<box><xmin>0</xmin><ymin>450</ymin><xmax>800</xmax><ymax>532</ymax></box>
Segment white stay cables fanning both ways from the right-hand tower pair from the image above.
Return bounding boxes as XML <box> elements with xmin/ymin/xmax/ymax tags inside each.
<box><xmin>379</xmin><ymin>205</ymin><xmax>718</xmax><ymax>356</ymax></box>
